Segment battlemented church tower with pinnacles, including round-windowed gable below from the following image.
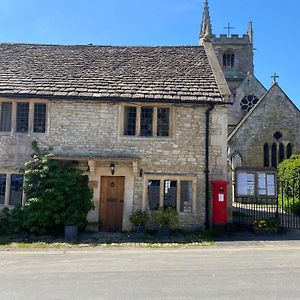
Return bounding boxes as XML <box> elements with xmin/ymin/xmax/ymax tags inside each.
<box><xmin>199</xmin><ymin>0</ymin><xmax>266</xmax><ymax>130</ymax></box>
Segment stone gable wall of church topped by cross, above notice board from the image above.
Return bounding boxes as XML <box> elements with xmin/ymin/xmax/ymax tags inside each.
<box><xmin>229</xmin><ymin>84</ymin><xmax>300</xmax><ymax>167</ymax></box>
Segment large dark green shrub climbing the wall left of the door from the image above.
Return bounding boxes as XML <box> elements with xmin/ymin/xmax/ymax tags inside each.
<box><xmin>2</xmin><ymin>144</ymin><xmax>94</xmax><ymax>234</ymax></box>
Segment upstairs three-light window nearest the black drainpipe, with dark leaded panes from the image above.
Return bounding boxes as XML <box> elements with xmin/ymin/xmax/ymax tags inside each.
<box><xmin>123</xmin><ymin>106</ymin><xmax>170</xmax><ymax>137</ymax></box>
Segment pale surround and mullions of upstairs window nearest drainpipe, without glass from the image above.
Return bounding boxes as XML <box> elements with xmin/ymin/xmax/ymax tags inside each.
<box><xmin>119</xmin><ymin>103</ymin><xmax>175</xmax><ymax>140</ymax></box>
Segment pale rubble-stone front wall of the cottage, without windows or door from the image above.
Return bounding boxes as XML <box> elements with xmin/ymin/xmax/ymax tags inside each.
<box><xmin>0</xmin><ymin>100</ymin><xmax>227</xmax><ymax>229</ymax></box>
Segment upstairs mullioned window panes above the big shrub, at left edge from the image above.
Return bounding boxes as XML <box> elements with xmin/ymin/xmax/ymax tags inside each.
<box><xmin>0</xmin><ymin>101</ymin><xmax>47</xmax><ymax>133</ymax></box>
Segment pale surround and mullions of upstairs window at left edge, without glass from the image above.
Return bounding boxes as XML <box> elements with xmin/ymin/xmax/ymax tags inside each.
<box><xmin>0</xmin><ymin>98</ymin><xmax>50</xmax><ymax>135</ymax></box>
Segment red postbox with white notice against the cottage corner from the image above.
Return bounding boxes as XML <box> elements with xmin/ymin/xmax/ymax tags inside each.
<box><xmin>211</xmin><ymin>180</ymin><xmax>228</xmax><ymax>225</ymax></box>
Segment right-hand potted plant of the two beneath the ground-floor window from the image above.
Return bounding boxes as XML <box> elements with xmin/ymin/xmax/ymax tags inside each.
<box><xmin>152</xmin><ymin>207</ymin><xmax>178</xmax><ymax>236</ymax></box>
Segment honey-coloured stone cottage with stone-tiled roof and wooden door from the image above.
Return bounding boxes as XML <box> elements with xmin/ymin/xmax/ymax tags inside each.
<box><xmin>0</xmin><ymin>42</ymin><xmax>230</xmax><ymax>231</ymax></box>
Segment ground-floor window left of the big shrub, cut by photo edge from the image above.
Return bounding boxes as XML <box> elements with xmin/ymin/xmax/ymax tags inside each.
<box><xmin>0</xmin><ymin>173</ymin><xmax>24</xmax><ymax>206</ymax></box>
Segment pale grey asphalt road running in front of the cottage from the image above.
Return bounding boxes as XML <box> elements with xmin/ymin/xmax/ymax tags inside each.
<box><xmin>0</xmin><ymin>242</ymin><xmax>300</xmax><ymax>300</ymax></box>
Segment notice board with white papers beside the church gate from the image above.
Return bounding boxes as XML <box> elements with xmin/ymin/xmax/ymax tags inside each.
<box><xmin>235</xmin><ymin>168</ymin><xmax>277</xmax><ymax>198</ymax></box>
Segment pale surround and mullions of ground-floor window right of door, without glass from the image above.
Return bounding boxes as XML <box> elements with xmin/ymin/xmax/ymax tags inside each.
<box><xmin>143</xmin><ymin>174</ymin><xmax>197</xmax><ymax>215</ymax></box>
